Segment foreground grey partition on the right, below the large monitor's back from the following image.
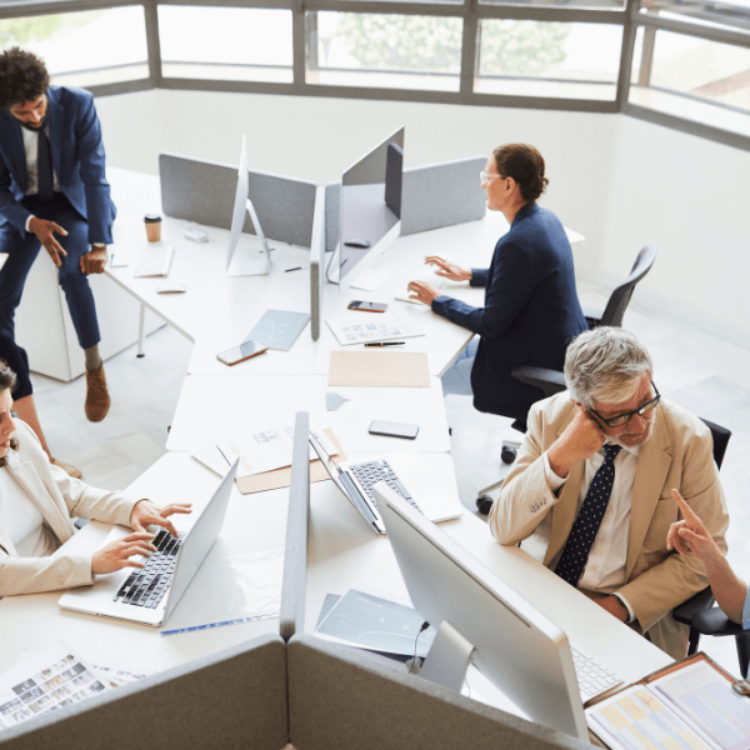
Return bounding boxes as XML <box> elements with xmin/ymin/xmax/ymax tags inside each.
<box><xmin>287</xmin><ymin>635</ymin><xmax>590</xmax><ymax>750</ymax></box>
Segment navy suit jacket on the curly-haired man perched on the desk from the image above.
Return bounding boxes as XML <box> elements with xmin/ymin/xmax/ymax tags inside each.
<box><xmin>0</xmin><ymin>86</ymin><xmax>116</xmax><ymax>245</ymax></box>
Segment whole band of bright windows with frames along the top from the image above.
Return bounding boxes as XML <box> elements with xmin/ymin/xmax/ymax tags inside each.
<box><xmin>0</xmin><ymin>0</ymin><xmax>750</xmax><ymax>150</ymax></box>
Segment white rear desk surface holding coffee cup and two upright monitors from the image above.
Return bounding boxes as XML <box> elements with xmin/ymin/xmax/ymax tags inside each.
<box><xmin>106</xmin><ymin>168</ymin><xmax>583</xmax><ymax>382</ymax></box>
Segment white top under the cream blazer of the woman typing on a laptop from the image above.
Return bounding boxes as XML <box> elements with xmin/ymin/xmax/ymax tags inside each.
<box><xmin>0</xmin><ymin>469</ymin><xmax>57</xmax><ymax>557</ymax></box>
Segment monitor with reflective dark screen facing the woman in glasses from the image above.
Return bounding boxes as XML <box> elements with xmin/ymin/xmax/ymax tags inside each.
<box><xmin>328</xmin><ymin>127</ymin><xmax>404</xmax><ymax>283</ymax></box>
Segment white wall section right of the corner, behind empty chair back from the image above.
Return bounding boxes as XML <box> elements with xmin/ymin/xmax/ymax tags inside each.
<box><xmin>600</xmin><ymin>117</ymin><xmax>750</xmax><ymax>346</ymax></box>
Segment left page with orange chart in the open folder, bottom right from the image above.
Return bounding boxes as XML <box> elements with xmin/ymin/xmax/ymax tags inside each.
<box><xmin>586</xmin><ymin>688</ymin><xmax>719</xmax><ymax>750</ymax></box>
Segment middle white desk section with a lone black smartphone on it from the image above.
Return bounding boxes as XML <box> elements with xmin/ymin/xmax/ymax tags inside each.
<box><xmin>167</xmin><ymin>375</ymin><xmax>450</xmax><ymax>455</ymax></box>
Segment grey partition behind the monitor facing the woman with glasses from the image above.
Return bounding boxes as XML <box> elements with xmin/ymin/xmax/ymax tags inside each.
<box><xmin>326</xmin><ymin>156</ymin><xmax>487</xmax><ymax>251</ymax></box>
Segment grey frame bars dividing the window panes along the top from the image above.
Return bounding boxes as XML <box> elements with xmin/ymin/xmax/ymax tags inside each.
<box><xmin>2</xmin><ymin>0</ymin><xmax>750</xmax><ymax>151</ymax></box>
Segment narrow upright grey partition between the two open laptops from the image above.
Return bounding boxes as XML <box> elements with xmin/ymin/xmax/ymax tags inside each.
<box><xmin>279</xmin><ymin>411</ymin><xmax>310</xmax><ymax>641</ymax></box>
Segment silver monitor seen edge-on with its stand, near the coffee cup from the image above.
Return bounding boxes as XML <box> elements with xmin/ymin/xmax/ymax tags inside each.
<box><xmin>231</xmin><ymin>135</ymin><xmax>271</xmax><ymax>276</ymax></box>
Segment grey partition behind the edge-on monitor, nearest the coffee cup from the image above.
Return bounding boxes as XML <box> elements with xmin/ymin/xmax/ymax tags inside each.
<box><xmin>159</xmin><ymin>154</ymin><xmax>316</xmax><ymax>247</ymax></box>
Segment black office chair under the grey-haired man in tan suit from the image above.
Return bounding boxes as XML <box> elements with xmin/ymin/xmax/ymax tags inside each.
<box><xmin>672</xmin><ymin>419</ymin><xmax>750</xmax><ymax>679</ymax></box>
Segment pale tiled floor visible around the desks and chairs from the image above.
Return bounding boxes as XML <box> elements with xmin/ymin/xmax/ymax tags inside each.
<box><xmin>26</xmin><ymin>284</ymin><xmax>750</xmax><ymax>672</ymax></box>
